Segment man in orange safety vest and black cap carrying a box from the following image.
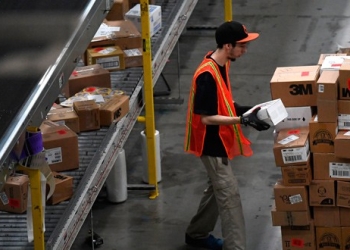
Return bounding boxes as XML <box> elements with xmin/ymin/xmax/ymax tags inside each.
<box><xmin>185</xmin><ymin>21</ymin><xmax>270</xmax><ymax>250</ymax></box>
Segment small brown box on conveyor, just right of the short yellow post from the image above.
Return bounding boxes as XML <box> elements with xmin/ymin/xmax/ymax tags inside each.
<box><xmin>46</xmin><ymin>172</ymin><xmax>73</xmax><ymax>205</ymax></box>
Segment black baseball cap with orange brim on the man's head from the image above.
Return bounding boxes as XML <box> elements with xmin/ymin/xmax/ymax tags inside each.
<box><xmin>215</xmin><ymin>21</ymin><xmax>259</xmax><ymax>45</ymax></box>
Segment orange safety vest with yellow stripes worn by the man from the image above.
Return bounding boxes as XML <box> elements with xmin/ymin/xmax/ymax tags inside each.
<box><xmin>185</xmin><ymin>52</ymin><xmax>253</xmax><ymax>159</ymax></box>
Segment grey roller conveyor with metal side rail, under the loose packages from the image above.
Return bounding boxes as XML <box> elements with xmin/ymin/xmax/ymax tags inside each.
<box><xmin>0</xmin><ymin>0</ymin><xmax>197</xmax><ymax>250</ymax></box>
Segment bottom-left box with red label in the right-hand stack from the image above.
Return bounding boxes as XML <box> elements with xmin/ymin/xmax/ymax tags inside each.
<box><xmin>281</xmin><ymin>220</ymin><xmax>316</xmax><ymax>250</ymax></box>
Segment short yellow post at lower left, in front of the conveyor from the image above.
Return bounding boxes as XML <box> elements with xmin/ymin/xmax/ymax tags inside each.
<box><xmin>17</xmin><ymin>166</ymin><xmax>45</xmax><ymax>250</ymax></box>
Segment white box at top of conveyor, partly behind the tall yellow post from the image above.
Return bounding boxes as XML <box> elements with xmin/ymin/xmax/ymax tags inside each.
<box><xmin>125</xmin><ymin>4</ymin><xmax>162</xmax><ymax>37</ymax></box>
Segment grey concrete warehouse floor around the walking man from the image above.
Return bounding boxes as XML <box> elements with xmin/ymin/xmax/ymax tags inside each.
<box><xmin>72</xmin><ymin>0</ymin><xmax>350</xmax><ymax>250</ymax></box>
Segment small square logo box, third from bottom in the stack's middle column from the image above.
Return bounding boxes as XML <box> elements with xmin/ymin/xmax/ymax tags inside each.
<box><xmin>309</xmin><ymin>180</ymin><xmax>336</xmax><ymax>207</ymax></box>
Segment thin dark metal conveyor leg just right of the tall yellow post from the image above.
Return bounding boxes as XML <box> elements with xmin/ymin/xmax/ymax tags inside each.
<box><xmin>154</xmin><ymin>41</ymin><xmax>184</xmax><ymax>105</ymax></box>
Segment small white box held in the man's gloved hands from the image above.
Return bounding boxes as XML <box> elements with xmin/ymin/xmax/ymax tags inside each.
<box><xmin>243</xmin><ymin>99</ymin><xmax>288</xmax><ymax>125</ymax></box>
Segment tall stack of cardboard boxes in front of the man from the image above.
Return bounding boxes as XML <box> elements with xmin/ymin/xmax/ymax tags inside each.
<box><xmin>270</xmin><ymin>54</ymin><xmax>350</xmax><ymax>250</ymax></box>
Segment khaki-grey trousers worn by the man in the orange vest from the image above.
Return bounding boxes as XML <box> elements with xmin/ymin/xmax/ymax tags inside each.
<box><xmin>186</xmin><ymin>156</ymin><xmax>246</xmax><ymax>250</ymax></box>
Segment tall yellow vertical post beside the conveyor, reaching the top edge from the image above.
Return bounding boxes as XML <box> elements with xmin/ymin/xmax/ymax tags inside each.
<box><xmin>140</xmin><ymin>0</ymin><xmax>159</xmax><ymax>199</ymax></box>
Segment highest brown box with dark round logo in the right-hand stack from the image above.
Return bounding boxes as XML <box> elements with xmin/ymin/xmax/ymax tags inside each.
<box><xmin>309</xmin><ymin>116</ymin><xmax>338</xmax><ymax>153</ymax></box>
